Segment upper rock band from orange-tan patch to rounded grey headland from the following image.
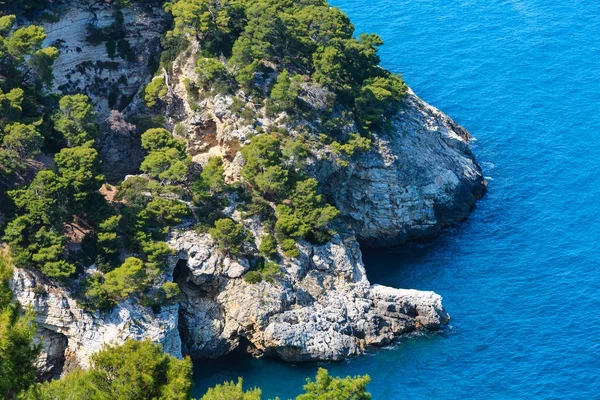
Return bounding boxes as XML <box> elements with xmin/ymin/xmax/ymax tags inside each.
<box><xmin>167</xmin><ymin>51</ymin><xmax>487</xmax><ymax>247</ymax></box>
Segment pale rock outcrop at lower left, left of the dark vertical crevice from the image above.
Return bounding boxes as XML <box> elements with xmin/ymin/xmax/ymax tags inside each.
<box><xmin>10</xmin><ymin>269</ymin><xmax>181</xmax><ymax>379</ymax></box>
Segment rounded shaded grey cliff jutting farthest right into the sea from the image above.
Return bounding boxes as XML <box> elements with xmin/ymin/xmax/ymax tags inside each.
<box><xmin>315</xmin><ymin>90</ymin><xmax>487</xmax><ymax>247</ymax></box>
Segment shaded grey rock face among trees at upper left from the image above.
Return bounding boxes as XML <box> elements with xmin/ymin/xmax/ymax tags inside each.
<box><xmin>43</xmin><ymin>0</ymin><xmax>168</xmax><ymax>181</ymax></box>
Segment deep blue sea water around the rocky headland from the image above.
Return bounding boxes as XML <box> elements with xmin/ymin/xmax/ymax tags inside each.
<box><xmin>196</xmin><ymin>0</ymin><xmax>600</xmax><ymax>399</ymax></box>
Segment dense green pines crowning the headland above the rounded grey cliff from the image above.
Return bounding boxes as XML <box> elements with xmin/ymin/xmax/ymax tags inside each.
<box><xmin>165</xmin><ymin>0</ymin><xmax>406</xmax><ymax>129</ymax></box>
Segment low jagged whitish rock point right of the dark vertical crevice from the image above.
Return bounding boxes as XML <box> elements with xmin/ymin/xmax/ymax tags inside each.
<box><xmin>169</xmin><ymin>231</ymin><xmax>449</xmax><ymax>361</ymax></box>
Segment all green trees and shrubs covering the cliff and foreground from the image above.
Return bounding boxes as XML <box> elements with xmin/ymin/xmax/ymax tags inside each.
<box><xmin>0</xmin><ymin>0</ymin><xmax>398</xmax><ymax>394</ymax></box>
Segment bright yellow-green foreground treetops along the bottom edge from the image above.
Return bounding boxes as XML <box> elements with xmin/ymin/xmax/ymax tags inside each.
<box><xmin>24</xmin><ymin>340</ymin><xmax>371</xmax><ymax>400</ymax></box>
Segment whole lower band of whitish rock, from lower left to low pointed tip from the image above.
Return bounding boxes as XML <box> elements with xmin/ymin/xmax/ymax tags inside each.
<box><xmin>11</xmin><ymin>230</ymin><xmax>449</xmax><ymax>378</ymax></box>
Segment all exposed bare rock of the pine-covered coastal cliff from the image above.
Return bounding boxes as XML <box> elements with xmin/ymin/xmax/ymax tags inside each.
<box><xmin>12</xmin><ymin>2</ymin><xmax>486</xmax><ymax>377</ymax></box>
